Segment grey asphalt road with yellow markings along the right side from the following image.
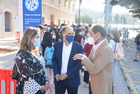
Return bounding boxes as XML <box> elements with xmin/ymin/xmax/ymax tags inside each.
<box><xmin>123</xmin><ymin>31</ymin><xmax>140</xmax><ymax>94</ymax></box>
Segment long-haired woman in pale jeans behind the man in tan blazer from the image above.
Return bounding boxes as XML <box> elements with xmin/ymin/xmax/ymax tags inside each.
<box><xmin>110</xmin><ymin>30</ymin><xmax>120</xmax><ymax>86</ymax></box>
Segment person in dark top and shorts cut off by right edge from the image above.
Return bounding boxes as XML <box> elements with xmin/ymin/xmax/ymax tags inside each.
<box><xmin>133</xmin><ymin>34</ymin><xmax>140</xmax><ymax>62</ymax></box>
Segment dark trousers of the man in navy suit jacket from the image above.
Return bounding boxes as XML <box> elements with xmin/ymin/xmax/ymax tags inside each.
<box><xmin>55</xmin><ymin>79</ymin><xmax>78</xmax><ymax>94</ymax></box>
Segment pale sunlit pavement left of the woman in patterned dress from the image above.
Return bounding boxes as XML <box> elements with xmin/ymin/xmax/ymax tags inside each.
<box><xmin>0</xmin><ymin>37</ymin><xmax>19</xmax><ymax>69</ymax></box>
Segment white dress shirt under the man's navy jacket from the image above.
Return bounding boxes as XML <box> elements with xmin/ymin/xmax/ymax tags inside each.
<box><xmin>61</xmin><ymin>42</ymin><xmax>73</xmax><ymax>74</ymax></box>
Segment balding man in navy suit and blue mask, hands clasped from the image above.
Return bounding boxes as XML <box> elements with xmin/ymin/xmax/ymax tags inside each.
<box><xmin>52</xmin><ymin>26</ymin><xmax>83</xmax><ymax>94</ymax></box>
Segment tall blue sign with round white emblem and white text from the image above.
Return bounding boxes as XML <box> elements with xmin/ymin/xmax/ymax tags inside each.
<box><xmin>22</xmin><ymin>0</ymin><xmax>42</xmax><ymax>32</ymax></box>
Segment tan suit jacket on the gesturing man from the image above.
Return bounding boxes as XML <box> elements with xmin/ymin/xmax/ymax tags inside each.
<box><xmin>82</xmin><ymin>40</ymin><xmax>114</xmax><ymax>94</ymax></box>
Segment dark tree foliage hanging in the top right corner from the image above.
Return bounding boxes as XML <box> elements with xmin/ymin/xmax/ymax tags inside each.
<box><xmin>110</xmin><ymin>0</ymin><xmax>140</xmax><ymax>19</ymax></box>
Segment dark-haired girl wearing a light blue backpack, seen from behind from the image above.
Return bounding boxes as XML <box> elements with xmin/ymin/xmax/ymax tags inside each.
<box><xmin>42</xmin><ymin>32</ymin><xmax>54</xmax><ymax>92</ymax></box>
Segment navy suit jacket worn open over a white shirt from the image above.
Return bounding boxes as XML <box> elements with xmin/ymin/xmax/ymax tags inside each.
<box><xmin>52</xmin><ymin>41</ymin><xmax>83</xmax><ymax>87</ymax></box>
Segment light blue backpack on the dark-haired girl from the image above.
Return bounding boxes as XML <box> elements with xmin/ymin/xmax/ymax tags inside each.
<box><xmin>44</xmin><ymin>46</ymin><xmax>54</xmax><ymax>65</ymax></box>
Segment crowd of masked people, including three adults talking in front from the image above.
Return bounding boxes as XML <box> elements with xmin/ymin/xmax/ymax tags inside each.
<box><xmin>12</xmin><ymin>24</ymin><xmax>130</xmax><ymax>94</ymax></box>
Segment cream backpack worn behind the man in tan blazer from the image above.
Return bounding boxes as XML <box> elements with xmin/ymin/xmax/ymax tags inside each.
<box><xmin>114</xmin><ymin>43</ymin><xmax>124</xmax><ymax>60</ymax></box>
